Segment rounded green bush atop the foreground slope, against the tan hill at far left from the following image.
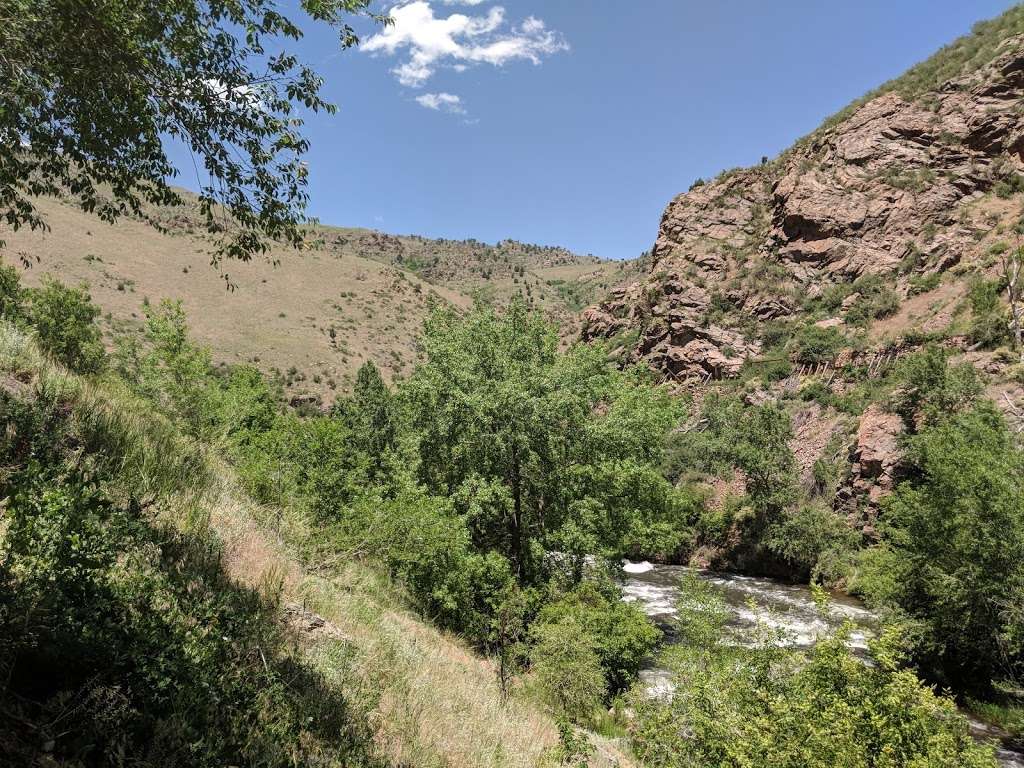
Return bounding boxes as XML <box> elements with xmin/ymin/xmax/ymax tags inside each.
<box><xmin>23</xmin><ymin>278</ymin><xmax>106</xmax><ymax>374</ymax></box>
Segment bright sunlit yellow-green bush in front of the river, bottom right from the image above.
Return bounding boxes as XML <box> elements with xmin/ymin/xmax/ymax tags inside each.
<box><xmin>631</xmin><ymin>579</ymin><xmax>995</xmax><ymax>768</ymax></box>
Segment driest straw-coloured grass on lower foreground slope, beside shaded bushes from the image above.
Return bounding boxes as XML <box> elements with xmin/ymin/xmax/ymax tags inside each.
<box><xmin>200</xmin><ymin>474</ymin><xmax>632</xmax><ymax>768</ymax></box>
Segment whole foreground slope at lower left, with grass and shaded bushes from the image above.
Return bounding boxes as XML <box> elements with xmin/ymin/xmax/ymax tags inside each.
<box><xmin>0</xmin><ymin>322</ymin><xmax>631</xmax><ymax>768</ymax></box>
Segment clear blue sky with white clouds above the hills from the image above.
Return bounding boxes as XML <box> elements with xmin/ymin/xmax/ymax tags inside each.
<box><xmin>180</xmin><ymin>0</ymin><xmax>1014</xmax><ymax>258</ymax></box>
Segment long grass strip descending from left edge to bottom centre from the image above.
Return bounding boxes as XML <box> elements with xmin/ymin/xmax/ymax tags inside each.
<box><xmin>0</xmin><ymin>323</ymin><xmax>632</xmax><ymax>768</ymax></box>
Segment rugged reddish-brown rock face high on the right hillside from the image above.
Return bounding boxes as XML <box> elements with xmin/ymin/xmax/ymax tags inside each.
<box><xmin>583</xmin><ymin>37</ymin><xmax>1024</xmax><ymax>381</ymax></box>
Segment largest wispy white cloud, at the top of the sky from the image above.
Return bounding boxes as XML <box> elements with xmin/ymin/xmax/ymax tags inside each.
<box><xmin>362</xmin><ymin>0</ymin><xmax>568</xmax><ymax>88</ymax></box>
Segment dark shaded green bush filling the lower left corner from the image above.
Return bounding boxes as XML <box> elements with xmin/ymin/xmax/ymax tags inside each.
<box><xmin>0</xmin><ymin>465</ymin><xmax>376</xmax><ymax>768</ymax></box>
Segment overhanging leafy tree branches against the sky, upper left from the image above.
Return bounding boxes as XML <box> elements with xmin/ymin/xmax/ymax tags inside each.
<box><xmin>0</xmin><ymin>0</ymin><xmax>387</xmax><ymax>260</ymax></box>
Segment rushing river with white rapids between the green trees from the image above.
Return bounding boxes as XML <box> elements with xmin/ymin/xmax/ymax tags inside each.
<box><xmin>623</xmin><ymin>561</ymin><xmax>1024</xmax><ymax>768</ymax></box>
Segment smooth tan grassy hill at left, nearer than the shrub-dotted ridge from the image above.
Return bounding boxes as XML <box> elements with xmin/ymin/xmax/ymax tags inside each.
<box><xmin>3</xmin><ymin>195</ymin><xmax>470</xmax><ymax>396</ymax></box>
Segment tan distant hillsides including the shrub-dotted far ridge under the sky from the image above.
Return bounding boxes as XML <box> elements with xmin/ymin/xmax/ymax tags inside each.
<box><xmin>0</xmin><ymin>193</ymin><xmax>637</xmax><ymax>401</ymax></box>
